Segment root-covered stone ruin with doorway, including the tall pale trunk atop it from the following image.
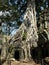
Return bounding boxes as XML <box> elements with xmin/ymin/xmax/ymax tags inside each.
<box><xmin>1</xmin><ymin>1</ymin><xmax>38</xmax><ymax>60</ymax></box>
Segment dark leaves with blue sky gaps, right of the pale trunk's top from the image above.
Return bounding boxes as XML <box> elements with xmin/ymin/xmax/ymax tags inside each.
<box><xmin>35</xmin><ymin>0</ymin><xmax>49</xmax><ymax>16</ymax></box>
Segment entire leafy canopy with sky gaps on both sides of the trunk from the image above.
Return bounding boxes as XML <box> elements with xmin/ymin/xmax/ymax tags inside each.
<box><xmin>0</xmin><ymin>0</ymin><xmax>49</xmax><ymax>34</ymax></box>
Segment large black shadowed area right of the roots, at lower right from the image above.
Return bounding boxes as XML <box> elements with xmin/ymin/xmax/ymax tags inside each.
<box><xmin>31</xmin><ymin>41</ymin><xmax>49</xmax><ymax>63</ymax></box>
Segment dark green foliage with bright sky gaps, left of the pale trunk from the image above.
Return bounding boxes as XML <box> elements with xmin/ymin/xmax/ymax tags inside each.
<box><xmin>0</xmin><ymin>0</ymin><xmax>28</xmax><ymax>34</ymax></box>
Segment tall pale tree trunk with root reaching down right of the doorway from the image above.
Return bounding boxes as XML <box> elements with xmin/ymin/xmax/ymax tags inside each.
<box><xmin>24</xmin><ymin>0</ymin><xmax>38</xmax><ymax>58</ymax></box>
